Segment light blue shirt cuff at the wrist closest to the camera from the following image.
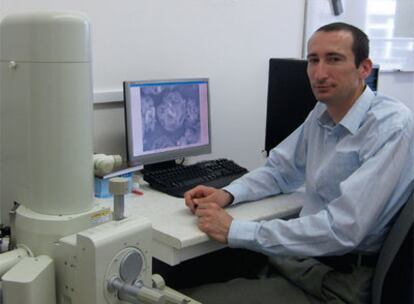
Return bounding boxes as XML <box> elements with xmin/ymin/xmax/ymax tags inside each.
<box><xmin>227</xmin><ymin>219</ymin><xmax>259</xmax><ymax>249</ymax></box>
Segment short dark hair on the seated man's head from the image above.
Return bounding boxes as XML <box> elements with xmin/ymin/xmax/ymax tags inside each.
<box><xmin>316</xmin><ymin>22</ymin><xmax>369</xmax><ymax>67</ymax></box>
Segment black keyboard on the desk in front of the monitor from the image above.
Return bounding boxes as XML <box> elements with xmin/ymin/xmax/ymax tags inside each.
<box><xmin>143</xmin><ymin>159</ymin><xmax>247</xmax><ymax>197</ymax></box>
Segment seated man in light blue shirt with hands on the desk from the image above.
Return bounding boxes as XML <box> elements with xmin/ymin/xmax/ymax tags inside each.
<box><xmin>185</xmin><ymin>23</ymin><xmax>414</xmax><ymax>303</ymax></box>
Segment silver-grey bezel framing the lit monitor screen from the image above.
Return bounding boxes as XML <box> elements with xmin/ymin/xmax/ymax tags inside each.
<box><xmin>123</xmin><ymin>77</ymin><xmax>211</xmax><ymax>165</ymax></box>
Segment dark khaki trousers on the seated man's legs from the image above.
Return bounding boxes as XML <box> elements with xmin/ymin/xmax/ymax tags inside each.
<box><xmin>182</xmin><ymin>257</ymin><xmax>373</xmax><ymax>304</ymax></box>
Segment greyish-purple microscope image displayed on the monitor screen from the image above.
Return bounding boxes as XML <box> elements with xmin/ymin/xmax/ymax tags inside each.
<box><xmin>141</xmin><ymin>84</ymin><xmax>201</xmax><ymax>151</ymax></box>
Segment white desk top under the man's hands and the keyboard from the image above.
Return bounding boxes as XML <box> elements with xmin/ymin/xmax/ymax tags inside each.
<box><xmin>96</xmin><ymin>186</ymin><xmax>303</xmax><ymax>266</ymax></box>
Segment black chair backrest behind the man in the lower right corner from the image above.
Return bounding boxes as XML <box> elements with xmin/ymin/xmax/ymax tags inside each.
<box><xmin>372</xmin><ymin>194</ymin><xmax>414</xmax><ymax>304</ymax></box>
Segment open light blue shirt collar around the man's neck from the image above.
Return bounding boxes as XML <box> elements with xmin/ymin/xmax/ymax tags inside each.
<box><xmin>319</xmin><ymin>86</ymin><xmax>375</xmax><ymax>134</ymax></box>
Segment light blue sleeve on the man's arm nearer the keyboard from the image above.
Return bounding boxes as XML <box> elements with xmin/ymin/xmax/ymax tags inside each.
<box><xmin>224</xmin><ymin>121</ymin><xmax>306</xmax><ymax>204</ymax></box>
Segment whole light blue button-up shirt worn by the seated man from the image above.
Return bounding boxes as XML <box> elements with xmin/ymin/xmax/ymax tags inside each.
<box><xmin>225</xmin><ymin>87</ymin><xmax>414</xmax><ymax>256</ymax></box>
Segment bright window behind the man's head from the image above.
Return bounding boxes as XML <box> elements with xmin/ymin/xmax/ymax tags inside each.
<box><xmin>304</xmin><ymin>0</ymin><xmax>414</xmax><ymax>71</ymax></box>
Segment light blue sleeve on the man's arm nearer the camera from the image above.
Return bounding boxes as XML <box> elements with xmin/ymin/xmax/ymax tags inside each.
<box><xmin>228</xmin><ymin>122</ymin><xmax>413</xmax><ymax>256</ymax></box>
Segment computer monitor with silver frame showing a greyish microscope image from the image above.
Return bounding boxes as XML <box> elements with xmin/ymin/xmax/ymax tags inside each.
<box><xmin>123</xmin><ymin>78</ymin><xmax>211</xmax><ymax>166</ymax></box>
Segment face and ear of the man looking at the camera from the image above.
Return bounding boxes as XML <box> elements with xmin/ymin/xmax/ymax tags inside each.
<box><xmin>307</xmin><ymin>31</ymin><xmax>370</xmax><ymax>105</ymax></box>
